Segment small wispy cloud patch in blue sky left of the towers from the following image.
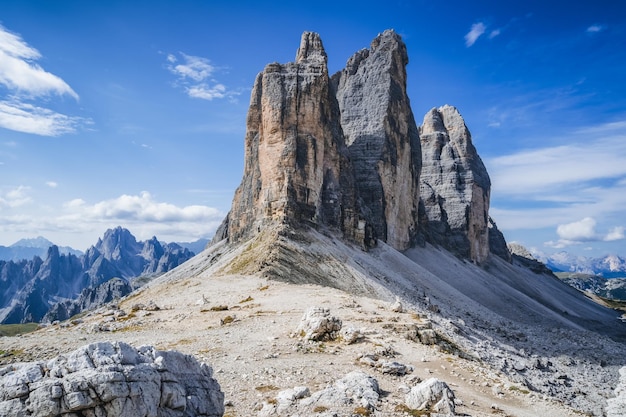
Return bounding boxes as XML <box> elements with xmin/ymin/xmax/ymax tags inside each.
<box><xmin>166</xmin><ymin>52</ymin><xmax>240</xmax><ymax>101</ymax></box>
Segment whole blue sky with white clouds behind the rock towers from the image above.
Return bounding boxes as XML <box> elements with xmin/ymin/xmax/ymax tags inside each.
<box><xmin>0</xmin><ymin>0</ymin><xmax>626</xmax><ymax>256</ymax></box>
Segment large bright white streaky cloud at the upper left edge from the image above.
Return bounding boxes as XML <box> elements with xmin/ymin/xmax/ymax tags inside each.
<box><xmin>0</xmin><ymin>25</ymin><xmax>89</xmax><ymax>136</ymax></box>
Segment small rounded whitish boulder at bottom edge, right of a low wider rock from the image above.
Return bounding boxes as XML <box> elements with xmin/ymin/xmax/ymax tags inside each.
<box><xmin>406</xmin><ymin>378</ymin><xmax>455</xmax><ymax>416</ymax></box>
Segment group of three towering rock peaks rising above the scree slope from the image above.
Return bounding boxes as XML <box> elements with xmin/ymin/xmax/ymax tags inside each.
<box><xmin>214</xmin><ymin>30</ymin><xmax>494</xmax><ymax>263</ymax></box>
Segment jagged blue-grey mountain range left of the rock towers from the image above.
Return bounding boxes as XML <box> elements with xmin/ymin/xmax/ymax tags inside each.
<box><xmin>0</xmin><ymin>227</ymin><xmax>200</xmax><ymax>324</ymax></box>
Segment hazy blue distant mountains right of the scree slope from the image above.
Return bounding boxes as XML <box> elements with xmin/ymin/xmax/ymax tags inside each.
<box><xmin>531</xmin><ymin>251</ymin><xmax>626</xmax><ymax>278</ymax></box>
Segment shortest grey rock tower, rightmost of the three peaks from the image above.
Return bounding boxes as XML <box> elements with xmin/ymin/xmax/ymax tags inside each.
<box><xmin>420</xmin><ymin>106</ymin><xmax>491</xmax><ymax>263</ymax></box>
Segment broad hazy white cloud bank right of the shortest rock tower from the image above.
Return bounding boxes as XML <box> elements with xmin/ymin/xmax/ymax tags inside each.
<box><xmin>486</xmin><ymin>122</ymin><xmax>626</xmax><ymax>248</ymax></box>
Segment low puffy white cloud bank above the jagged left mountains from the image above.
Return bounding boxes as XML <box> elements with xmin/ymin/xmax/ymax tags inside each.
<box><xmin>0</xmin><ymin>187</ymin><xmax>224</xmax><ymax>249</ymax></box>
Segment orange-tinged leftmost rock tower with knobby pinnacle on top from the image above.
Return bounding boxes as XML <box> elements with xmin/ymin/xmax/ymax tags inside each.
<box><xmin>227</xmin><ymin>32</ymin><xmax>355</xmax><ymax>241</ymax></box>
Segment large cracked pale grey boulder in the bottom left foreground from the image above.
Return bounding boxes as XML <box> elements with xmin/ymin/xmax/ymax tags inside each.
<box><xmin>0</xmin><ymin>342</ymin><xmax>224</xmax><ymax>417</ymax></box>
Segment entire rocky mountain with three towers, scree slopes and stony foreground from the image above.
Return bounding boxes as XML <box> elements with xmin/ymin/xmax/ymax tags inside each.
<box><xmin>0</xmin><ymin>30</ymin><xmax>626</xmax><ymax>417</ymax></box>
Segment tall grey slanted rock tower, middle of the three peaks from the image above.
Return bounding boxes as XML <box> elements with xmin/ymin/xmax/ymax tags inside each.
<box><xmin>333</xmin><ymin>30</ymin><xmax>421</xmax><ymax>250</ymax></box>
